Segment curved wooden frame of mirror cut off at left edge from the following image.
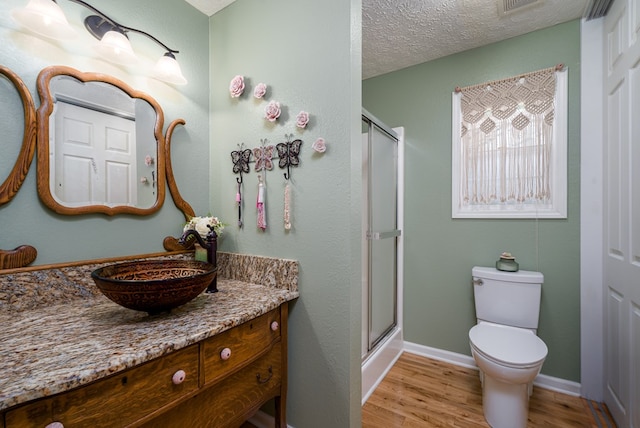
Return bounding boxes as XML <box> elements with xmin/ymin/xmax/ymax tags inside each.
<box><xmin>0</xmin><ymin>65</ymin><xmax>36</xmax><ymax>206</ymax></box>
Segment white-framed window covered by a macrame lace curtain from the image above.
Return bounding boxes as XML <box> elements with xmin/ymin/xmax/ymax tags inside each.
<box><xmin>452</xmin><ymin>67</ymin><xmax>567</xmax><ymax>218</ymax></box>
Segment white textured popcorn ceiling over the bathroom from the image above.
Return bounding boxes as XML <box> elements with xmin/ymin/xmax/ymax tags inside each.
<box><xmin>186</xmin><ymin>0</ymin><xmax>589</xmax><ymax>79</ymax></box>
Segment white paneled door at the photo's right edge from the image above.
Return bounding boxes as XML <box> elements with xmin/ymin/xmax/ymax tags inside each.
<box><xmin>603</xmin><ymin>0</ymin><xmax>640</xmax><ymax>428</ymax></box>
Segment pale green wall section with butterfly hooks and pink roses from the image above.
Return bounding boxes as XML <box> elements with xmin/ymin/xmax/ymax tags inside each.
<box><xmin>210</xmin><ymin>0</ymin><xmax>361</xmax><ymax>428</ymax></box>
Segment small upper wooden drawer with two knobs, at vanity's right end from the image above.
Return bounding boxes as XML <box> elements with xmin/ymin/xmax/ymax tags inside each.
<box><xmin>203</xmin><ymin>309</ymin><xmax>280</xmax><ymax>384</ymax></box>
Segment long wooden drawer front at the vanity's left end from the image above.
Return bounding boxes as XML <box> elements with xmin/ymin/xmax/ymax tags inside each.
<box><xmin>5</xmin><ymin>345</ymin><xmax>198</xmax><ymax>428</ymax></box>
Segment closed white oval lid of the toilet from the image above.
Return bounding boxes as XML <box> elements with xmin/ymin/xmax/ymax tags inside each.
<box><xmin>469</xmin><ymin>323</ymin><xmax>547</xmax><ymax>366</ymax></box>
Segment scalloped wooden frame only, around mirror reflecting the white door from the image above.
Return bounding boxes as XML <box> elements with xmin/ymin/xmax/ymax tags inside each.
<box><xmin>37</xmin><ymin>66</ymin><xmax>165</xmax><ymax>215</ymax></box>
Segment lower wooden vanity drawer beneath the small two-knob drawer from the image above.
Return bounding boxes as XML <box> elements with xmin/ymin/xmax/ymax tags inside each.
<box><xmin>140</xmin><ymin>344</ymin><xmax>283</xmax><ymax>428</ymax></box>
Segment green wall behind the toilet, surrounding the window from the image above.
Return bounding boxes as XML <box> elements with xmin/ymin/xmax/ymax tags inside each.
<box><xmin>362</xmin><ymin>21</ymin><xmax>580</xmax><ymax>382</ymax></box>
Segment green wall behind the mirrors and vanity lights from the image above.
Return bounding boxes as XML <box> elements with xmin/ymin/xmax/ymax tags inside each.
<box><xmin>0</xmin><ymin>0</ymin><xmax>210</xmax><ymax>264</ymax></box>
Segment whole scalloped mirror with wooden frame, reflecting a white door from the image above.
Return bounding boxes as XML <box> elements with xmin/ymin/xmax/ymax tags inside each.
<box><xmin>37</xmin><ymin>66</ymin><xmax>165</xmax><ymax>215</ymax></box>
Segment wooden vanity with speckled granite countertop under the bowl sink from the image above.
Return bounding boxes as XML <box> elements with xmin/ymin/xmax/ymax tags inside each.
<box><xmin>0</xmin><ymin>252</ymin><xmax>297</xmax><ymax>428</ymax></box>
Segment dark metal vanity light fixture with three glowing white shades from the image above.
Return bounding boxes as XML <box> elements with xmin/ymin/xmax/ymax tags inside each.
<box><xmin>11</xmin><ymin>0</ymin><xmax>187</xmax><ymax>85</ymax></box>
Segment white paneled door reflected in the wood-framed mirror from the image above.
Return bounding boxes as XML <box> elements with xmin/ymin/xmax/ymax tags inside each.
<box><xmin>50</xmin><ymin>101</ymin><xmax>137</xmax><ymax>206</ymax></box>
